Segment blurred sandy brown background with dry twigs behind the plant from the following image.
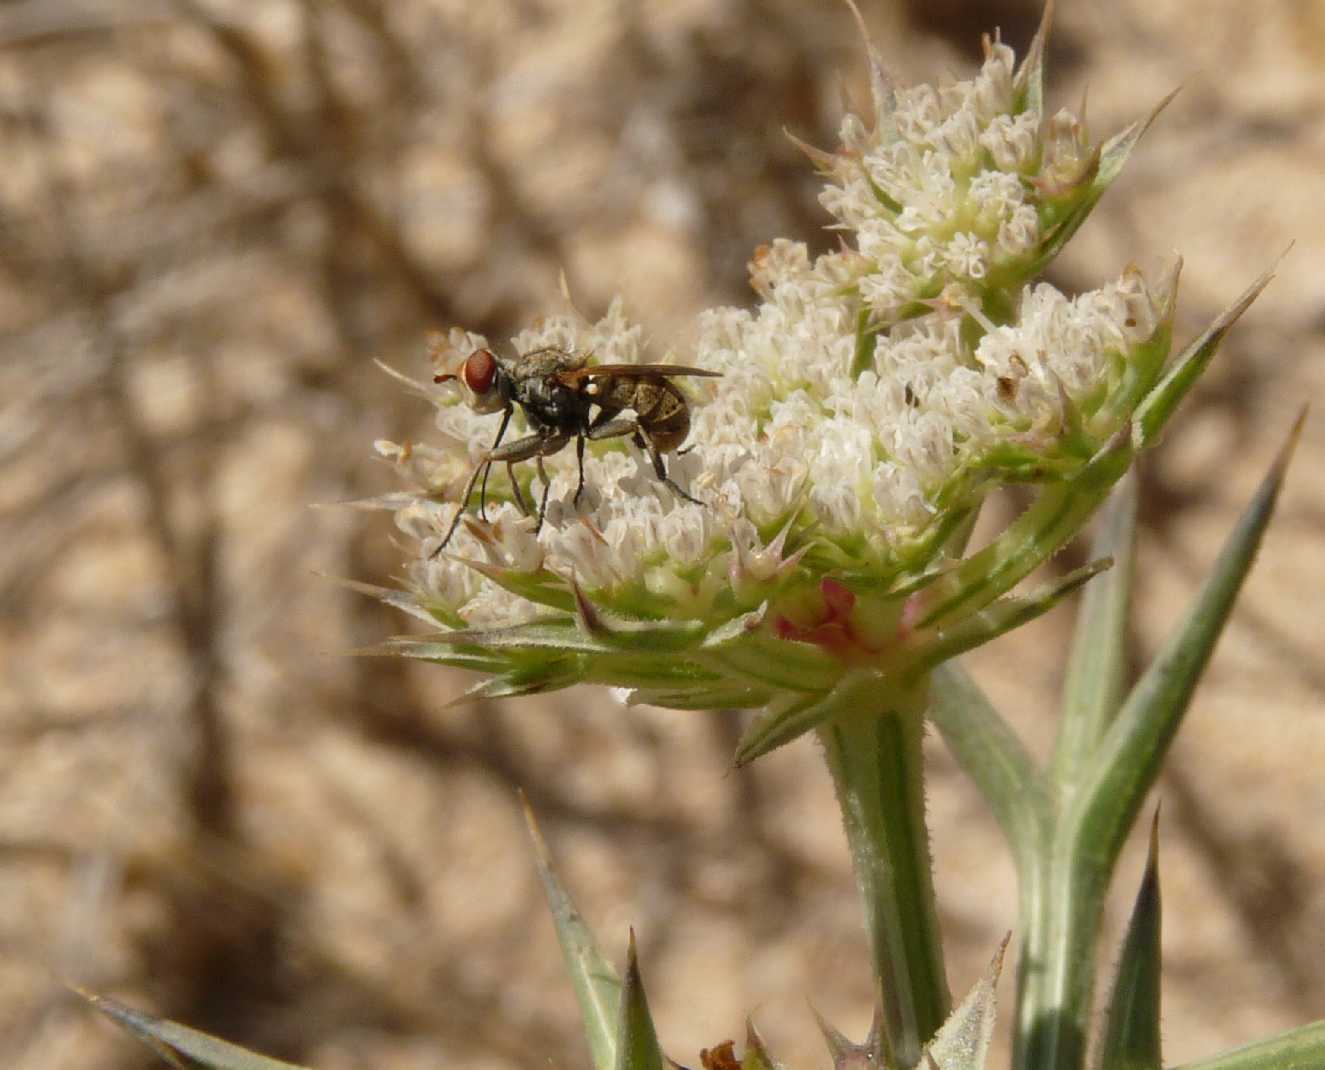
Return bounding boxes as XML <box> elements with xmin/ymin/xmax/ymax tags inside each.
<box><xmin>0</xmin><ymin>0</ymin><xmax>1325</xmax><ymax>1070</ymax></box>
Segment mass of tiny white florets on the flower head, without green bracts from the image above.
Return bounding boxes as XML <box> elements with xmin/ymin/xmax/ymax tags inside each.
<box><xmin>382</xmin><ymin>45</ymin><xmax>1163</xmax><ymax>625</ymax></box>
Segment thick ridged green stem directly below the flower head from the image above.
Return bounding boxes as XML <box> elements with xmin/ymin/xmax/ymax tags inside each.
<box><xmin>819</xmin><ymin>702</ymin><xmax>951</xmax><ymax>1070</ymax></box>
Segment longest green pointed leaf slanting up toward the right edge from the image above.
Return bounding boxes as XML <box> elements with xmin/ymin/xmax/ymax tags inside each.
<box><xmin>1065</xmin><ymin>411</ymin><xmax>1306</xmax><ymax>859</ymax></box>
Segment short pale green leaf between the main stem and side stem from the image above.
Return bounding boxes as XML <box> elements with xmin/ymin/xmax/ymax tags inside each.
<box><xmin>929</xmin><ymin>661</ymin><xmax>1052</xmax><ymax>879</ymax></box>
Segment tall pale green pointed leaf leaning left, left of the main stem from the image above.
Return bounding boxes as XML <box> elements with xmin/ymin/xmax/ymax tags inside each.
<box><xmin>519</xmin><ymin>792</ymin><xmax>621</xmax><ymax>1070</ymax></box>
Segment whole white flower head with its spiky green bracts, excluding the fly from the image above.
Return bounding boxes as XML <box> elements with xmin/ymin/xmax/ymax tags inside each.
<box><xmin>363</xmin><ymin>18</ymin><xmax>1263</xmax><ymax>760</ymax></box>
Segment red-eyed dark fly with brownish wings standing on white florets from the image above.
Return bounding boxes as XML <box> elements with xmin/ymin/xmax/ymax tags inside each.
<box><xmin>432</xmin><ymin>346</ymin><xmax>722</xmax><ymax>556</ymax></box>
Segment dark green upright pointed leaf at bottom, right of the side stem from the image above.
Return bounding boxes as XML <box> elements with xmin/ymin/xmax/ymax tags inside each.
<box><xmin>1100</xmin><ymin>812</ymin><xmax>1161</xmax><ymax>1070</ymax></box>
